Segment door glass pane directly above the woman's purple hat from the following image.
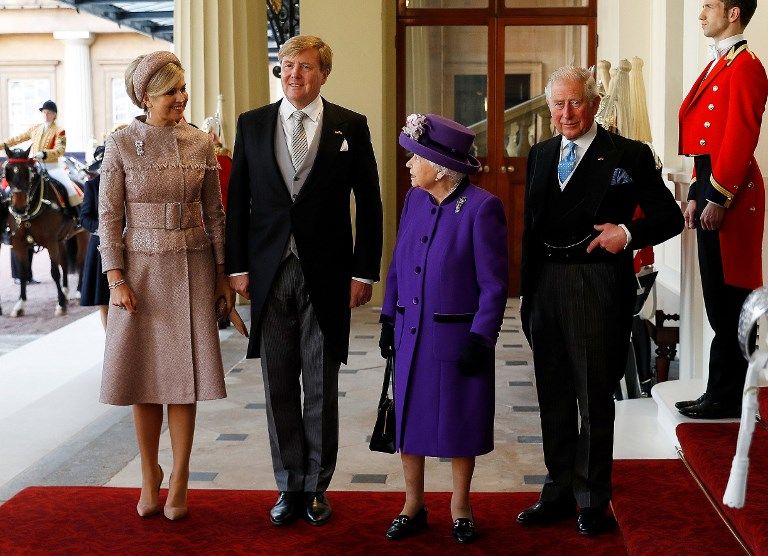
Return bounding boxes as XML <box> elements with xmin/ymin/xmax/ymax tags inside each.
<box><xmin>405</xmin><ymin>26</ymin><xmax>488</xmax><ymax>156</ymax></box>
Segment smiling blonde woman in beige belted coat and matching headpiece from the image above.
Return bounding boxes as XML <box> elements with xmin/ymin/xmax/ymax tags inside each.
<box><xmin>99</xmin><ymin>51</ymin><xmax>234</xmax><ymax>520</ymax></box>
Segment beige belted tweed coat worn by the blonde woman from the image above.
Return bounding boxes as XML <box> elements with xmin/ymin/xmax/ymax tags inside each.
<box><xmin>99</xmin><ymin>116</ymin><xmax>226</xmax><ymax>405</ymax></box>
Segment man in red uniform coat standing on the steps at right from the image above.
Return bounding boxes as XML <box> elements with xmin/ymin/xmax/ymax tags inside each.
<box><xmin>675</xmin><ymin>0</ymin><xmax>768</xmax><ymax>419</ymax></box>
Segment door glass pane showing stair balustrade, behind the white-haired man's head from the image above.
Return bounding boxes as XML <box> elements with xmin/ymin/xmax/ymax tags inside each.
<box><xmin>504</xmin><ymin>25</ymin><xmax>588</xmax><ymax>157</ymax></box>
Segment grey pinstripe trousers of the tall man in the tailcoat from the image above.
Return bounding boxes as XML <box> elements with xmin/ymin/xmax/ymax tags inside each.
<box><xmin>261</xmin><ymin>255</ymin><xmax>340</xmax><ymax>492</ymax></box>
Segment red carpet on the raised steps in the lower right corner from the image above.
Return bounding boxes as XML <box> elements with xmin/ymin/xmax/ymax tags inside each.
<box><xmin>676</xmin><ymin>423</ymin><xmax>768</xmax><ymax>555</ymax></box>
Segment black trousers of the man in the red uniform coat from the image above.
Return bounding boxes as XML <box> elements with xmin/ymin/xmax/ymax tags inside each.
<box><xmin>694</xmin><ymin>156</ymin><xmax>752</xmax><ymax>405</ymax></box>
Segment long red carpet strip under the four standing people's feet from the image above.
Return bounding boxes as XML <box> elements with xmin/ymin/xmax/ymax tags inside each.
<box><xmin>0</xmin><ymin>487</ymin><xmax>626</xmax><ymax>556</ymax></box>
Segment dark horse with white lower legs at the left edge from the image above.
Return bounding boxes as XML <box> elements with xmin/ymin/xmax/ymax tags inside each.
<box><xmin>4</xmin><ymin>146</ymin><xmax>89</xmax><ymax>317</ymax></box>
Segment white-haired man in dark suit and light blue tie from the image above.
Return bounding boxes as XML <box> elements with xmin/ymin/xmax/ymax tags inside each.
<box><xmin>517</xmin><ymin>67</ymin><xmax>683</xmax><ymax>535</ymax></box>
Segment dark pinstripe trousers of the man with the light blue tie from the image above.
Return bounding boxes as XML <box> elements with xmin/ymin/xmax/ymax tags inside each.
<box><xmin>530</xmin><ymin>263</ymin><xmax>632</xmax><ymax>508</ymax></box>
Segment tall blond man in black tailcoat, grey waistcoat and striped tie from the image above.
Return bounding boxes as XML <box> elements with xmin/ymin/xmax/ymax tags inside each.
<box><xmin>226</xmin><ymin>36</ymin><xmax>382</xmax><ymax>525</ymax></box>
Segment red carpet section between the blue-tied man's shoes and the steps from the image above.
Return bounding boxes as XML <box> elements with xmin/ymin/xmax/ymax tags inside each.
<box><xmin>613</xmin><ymin>459</ymin><xmax>744</xmax><ymax>556</ymax></box>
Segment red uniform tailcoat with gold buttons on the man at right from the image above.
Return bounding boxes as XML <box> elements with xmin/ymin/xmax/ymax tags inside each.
<box><xmin>679</xmin><ymin>43</ymin><xmax>768</xmax><ymax>289</ymax></box>
